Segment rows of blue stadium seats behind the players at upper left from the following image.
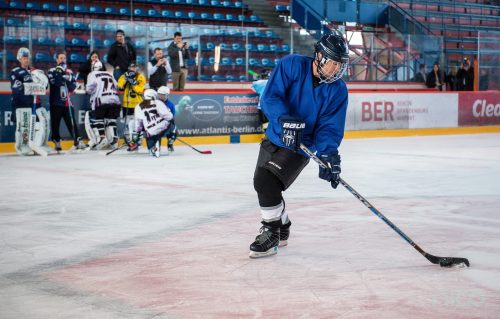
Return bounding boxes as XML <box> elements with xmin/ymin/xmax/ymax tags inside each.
<box><xmin>0</xmin><ymin>0</ymin><xmax>282</xmax><ymax>82</ymax></box>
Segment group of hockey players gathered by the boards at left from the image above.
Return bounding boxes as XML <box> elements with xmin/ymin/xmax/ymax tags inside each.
<box><xmin>11</xmin><ymin>48</ymin><xmax>177</xmax><ymax>157</ymax></box>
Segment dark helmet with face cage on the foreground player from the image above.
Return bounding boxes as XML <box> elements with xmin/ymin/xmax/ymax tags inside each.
<box><xmin>314</xmin><ymin>31</ymin><xmax>349</xmax><ymax>83</ymax></box>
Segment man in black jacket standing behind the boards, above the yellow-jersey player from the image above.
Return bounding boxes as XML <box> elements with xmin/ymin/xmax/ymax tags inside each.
<box><xmin>108</xmin><ymin>30</ymin><xmax>137</xmax><ymax>81</ymax></box>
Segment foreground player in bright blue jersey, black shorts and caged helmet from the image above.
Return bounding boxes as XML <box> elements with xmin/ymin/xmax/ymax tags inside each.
<box><xmin>250</xmin><ymin>32</ymin><xmax>349</xmax><ymax>258</ymax></box>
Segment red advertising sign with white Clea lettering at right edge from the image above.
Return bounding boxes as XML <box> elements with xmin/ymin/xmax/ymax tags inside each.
<box><xmin>458</xmin><ymin>91</ymin><xmax>500</xmax><ymax>126</ymax></box>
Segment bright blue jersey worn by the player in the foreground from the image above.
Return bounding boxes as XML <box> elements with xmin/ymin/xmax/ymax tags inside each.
<box><xmin>260</xmin><ymin>54</ymin><xmax>347</xmax><ymax>155</ymax></box>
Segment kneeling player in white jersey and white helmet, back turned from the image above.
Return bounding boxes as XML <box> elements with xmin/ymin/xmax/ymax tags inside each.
<box><xmin>132</xmin><ymin>89</ymin><xmax>173</xmax><ymax>157</ymax></box>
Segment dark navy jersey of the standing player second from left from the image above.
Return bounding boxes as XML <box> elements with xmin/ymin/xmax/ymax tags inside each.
<box><xmin>47</xmin><ymin>68</ymin><xmax>76</xmax><ymax>107</ymax></box>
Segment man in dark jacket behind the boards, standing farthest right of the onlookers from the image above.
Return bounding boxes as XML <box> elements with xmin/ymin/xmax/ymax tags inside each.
<box><xmin>167</xmin><ymin>32</ymin><xmax>190</xmax><ymax>91</ymax></box>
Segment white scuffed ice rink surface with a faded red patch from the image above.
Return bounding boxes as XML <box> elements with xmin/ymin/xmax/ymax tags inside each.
<box><xmin>0</xmin><ymin>134</ymin><xmax>500</xmax><ymax>319</ymax></box>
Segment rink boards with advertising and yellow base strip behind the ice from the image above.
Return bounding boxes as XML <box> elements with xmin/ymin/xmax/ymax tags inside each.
<box><xmin>0</xmin><ymin>90</ymin><xmax>500</xmax><ymax>152</ymax></box>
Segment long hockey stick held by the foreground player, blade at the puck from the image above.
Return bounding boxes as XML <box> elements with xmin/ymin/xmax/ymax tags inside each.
<box><xmin>300</xmin><ymin>144</ymin><xmax>469</xmax><ymax>267</ymax></box>
